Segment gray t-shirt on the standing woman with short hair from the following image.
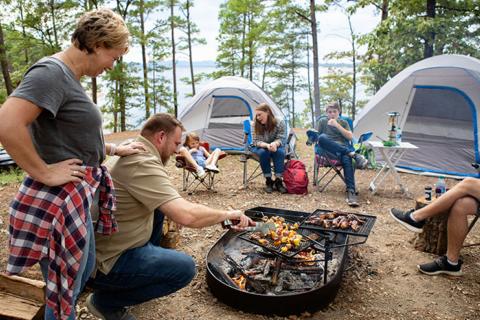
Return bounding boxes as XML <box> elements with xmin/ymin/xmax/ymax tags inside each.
<box><xmin>11</xmin><ymin>57</ymin><xmax>105</xmax><ymax>167</ymax></box>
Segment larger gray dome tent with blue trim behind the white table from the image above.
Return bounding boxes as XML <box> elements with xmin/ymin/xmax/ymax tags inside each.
<box><xmin>354</xmin><ymin>55</ymin><xmax>480</xmax><ymax>177</ymax></box>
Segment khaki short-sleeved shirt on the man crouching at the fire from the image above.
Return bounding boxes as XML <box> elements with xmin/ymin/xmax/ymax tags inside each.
<box><xmin>95</xmin><ymin>136</ymin><xmax>180</xmax><ymax>274</ymax></box>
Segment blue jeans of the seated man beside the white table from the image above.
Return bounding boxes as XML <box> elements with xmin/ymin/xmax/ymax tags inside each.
<box><xmin>318</xmin><ymin>133</ymin><xmax>355</xmax><ymax>191</ymax></box>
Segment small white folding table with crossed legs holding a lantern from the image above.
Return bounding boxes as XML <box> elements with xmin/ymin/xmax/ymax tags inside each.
<box><xmin>368</xmin><ymin>141</ymin><xmax>417</xmax><ymax>195</ymax></box>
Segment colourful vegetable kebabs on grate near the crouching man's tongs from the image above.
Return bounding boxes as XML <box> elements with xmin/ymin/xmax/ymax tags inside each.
<box><xmin>250</xmin><ymin>216</ymin><xmax>302</xmax><ymax>252</ymax></box>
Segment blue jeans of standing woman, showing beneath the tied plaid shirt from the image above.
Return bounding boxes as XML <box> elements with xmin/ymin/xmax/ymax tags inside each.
<box><xmin>40</xmin><ymin>212</ymin><xmax>95</xmax><ymax>320</ymax></box>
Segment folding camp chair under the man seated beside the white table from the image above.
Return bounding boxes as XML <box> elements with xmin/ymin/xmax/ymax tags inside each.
<box><xmin>307</xmin><ymin>117</ymin><xmax>373</xmax><ymax>192</ymax></box>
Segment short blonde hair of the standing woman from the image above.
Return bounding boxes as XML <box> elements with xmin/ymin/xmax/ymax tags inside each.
<box><xmin>72</xmin><ymin>8</ymin><xmax>130</xmax><ymax>54</ymax></box>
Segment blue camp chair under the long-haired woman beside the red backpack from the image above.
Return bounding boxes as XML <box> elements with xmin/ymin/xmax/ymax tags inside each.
<box><xmin>240</xmin><ymin>120</ymin><xmax>298</xmax><ymax>188</ymax></box>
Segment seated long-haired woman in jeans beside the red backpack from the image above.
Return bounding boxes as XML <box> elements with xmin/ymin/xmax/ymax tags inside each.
<box><xmin>252</xmin><ymin>103</ymin><xmax>287</xmax><ymax>193</ymax></box>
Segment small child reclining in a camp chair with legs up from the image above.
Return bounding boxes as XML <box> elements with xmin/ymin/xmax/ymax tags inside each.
<box><xmin>179</xmin><ymin>132</ymin><xmax>223</xmax><ymax>178</ymax></box>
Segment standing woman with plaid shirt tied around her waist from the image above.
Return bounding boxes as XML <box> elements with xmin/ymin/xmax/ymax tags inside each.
<box><xmin>0</xmin><ymin>9</ymin><xmax>143</xmax><ymax>319</ymax></box>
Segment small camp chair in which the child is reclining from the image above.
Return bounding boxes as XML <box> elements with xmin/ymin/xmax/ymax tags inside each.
<box><xmin>175</xmin><ymin>141</ymin><xmax>227</xmax><ymax>195</ymax></box>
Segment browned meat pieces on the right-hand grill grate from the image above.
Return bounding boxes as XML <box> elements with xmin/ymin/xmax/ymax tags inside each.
<box><xmin>306</xmin><ymin>211</ymin><xmax>365</xmax><ymax>231</ymax></box>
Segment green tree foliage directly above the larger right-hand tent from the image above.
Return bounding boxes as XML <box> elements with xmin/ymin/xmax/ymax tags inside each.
<box><xmin>360</xmin><ymin>0</ymin><xmax>480</xmax><ymax>93</ymax></box>
